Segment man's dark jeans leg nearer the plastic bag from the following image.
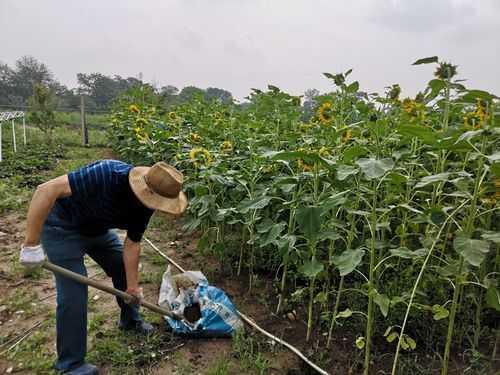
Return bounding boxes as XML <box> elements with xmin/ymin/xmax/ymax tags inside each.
<box><xmin>86</xmin><ymin>230</ymin><xmax>141</xmax><ymax>325</ymax></box>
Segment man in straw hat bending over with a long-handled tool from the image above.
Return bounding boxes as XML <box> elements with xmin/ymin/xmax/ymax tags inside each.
<box><xmin>20</xmin><ymin>160</ymin><xmax>187</xmax><ymax>375</ymax></box>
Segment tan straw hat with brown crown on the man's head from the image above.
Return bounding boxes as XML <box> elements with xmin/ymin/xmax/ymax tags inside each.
<box><xmin>128</xmin><ymin>161</ymin><xmax>188</xmax><ymax>215</ymax></box>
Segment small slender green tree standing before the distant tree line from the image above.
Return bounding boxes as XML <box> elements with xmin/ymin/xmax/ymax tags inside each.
<box><xmin>28</xmin><ymin>83</ymin><xmax>56</xmax><ymax>143</ymax></box>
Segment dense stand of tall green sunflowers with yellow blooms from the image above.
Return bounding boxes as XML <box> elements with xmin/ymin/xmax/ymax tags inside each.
<box><xmin>110</xmin><ymin>57</ymin><xmax>500</xmax><ymax>374</ymax></box>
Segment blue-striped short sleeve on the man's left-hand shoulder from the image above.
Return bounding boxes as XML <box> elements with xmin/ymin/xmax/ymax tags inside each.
<box><xmin>68</xmin><ymin>160</ymin><xmax>111</xmax><ymax>201</ymax></box>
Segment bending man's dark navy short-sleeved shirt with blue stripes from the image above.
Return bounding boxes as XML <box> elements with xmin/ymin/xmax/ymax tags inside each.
<box><xmin>56</xmin><ymin>160</ymin><xmax>154</xmax><ymax>242</ymax></box>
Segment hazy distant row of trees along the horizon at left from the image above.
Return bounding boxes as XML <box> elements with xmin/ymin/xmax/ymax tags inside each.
<box><xmin>0</xmin><ymin>56</ymin><xmax>233</xmax><ymax>112</ymax></box>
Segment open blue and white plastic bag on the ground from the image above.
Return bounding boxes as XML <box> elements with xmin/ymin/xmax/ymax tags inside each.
<box><xmin>158</xmin><ymin>266</ymin><xmax>243</xmax><ymax>337</ymax></box>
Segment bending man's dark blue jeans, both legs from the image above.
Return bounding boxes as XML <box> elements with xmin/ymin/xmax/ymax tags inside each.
<box><xmin>41</xmin><ymin>206</ymin><xmax>141</xmax><ymax>371</ymax></box>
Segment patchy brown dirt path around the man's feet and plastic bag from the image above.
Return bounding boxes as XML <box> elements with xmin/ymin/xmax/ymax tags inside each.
<box><xmin>0</xmin><ymin>210</ymin><xmax>305</xmax><ymax>375</ymax></box>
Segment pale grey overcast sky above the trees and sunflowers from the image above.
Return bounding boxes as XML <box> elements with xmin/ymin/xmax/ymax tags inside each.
<box><xmin>0</xmin><ymin>0</ymin><xmax>500</xmax><ymax>98</ymax></box>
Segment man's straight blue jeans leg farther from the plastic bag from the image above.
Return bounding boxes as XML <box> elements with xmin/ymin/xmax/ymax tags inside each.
<box><xmin>42</xmin><ymin>224</ymin><xmax>88</xmax><ymax>371</ymax></box>
